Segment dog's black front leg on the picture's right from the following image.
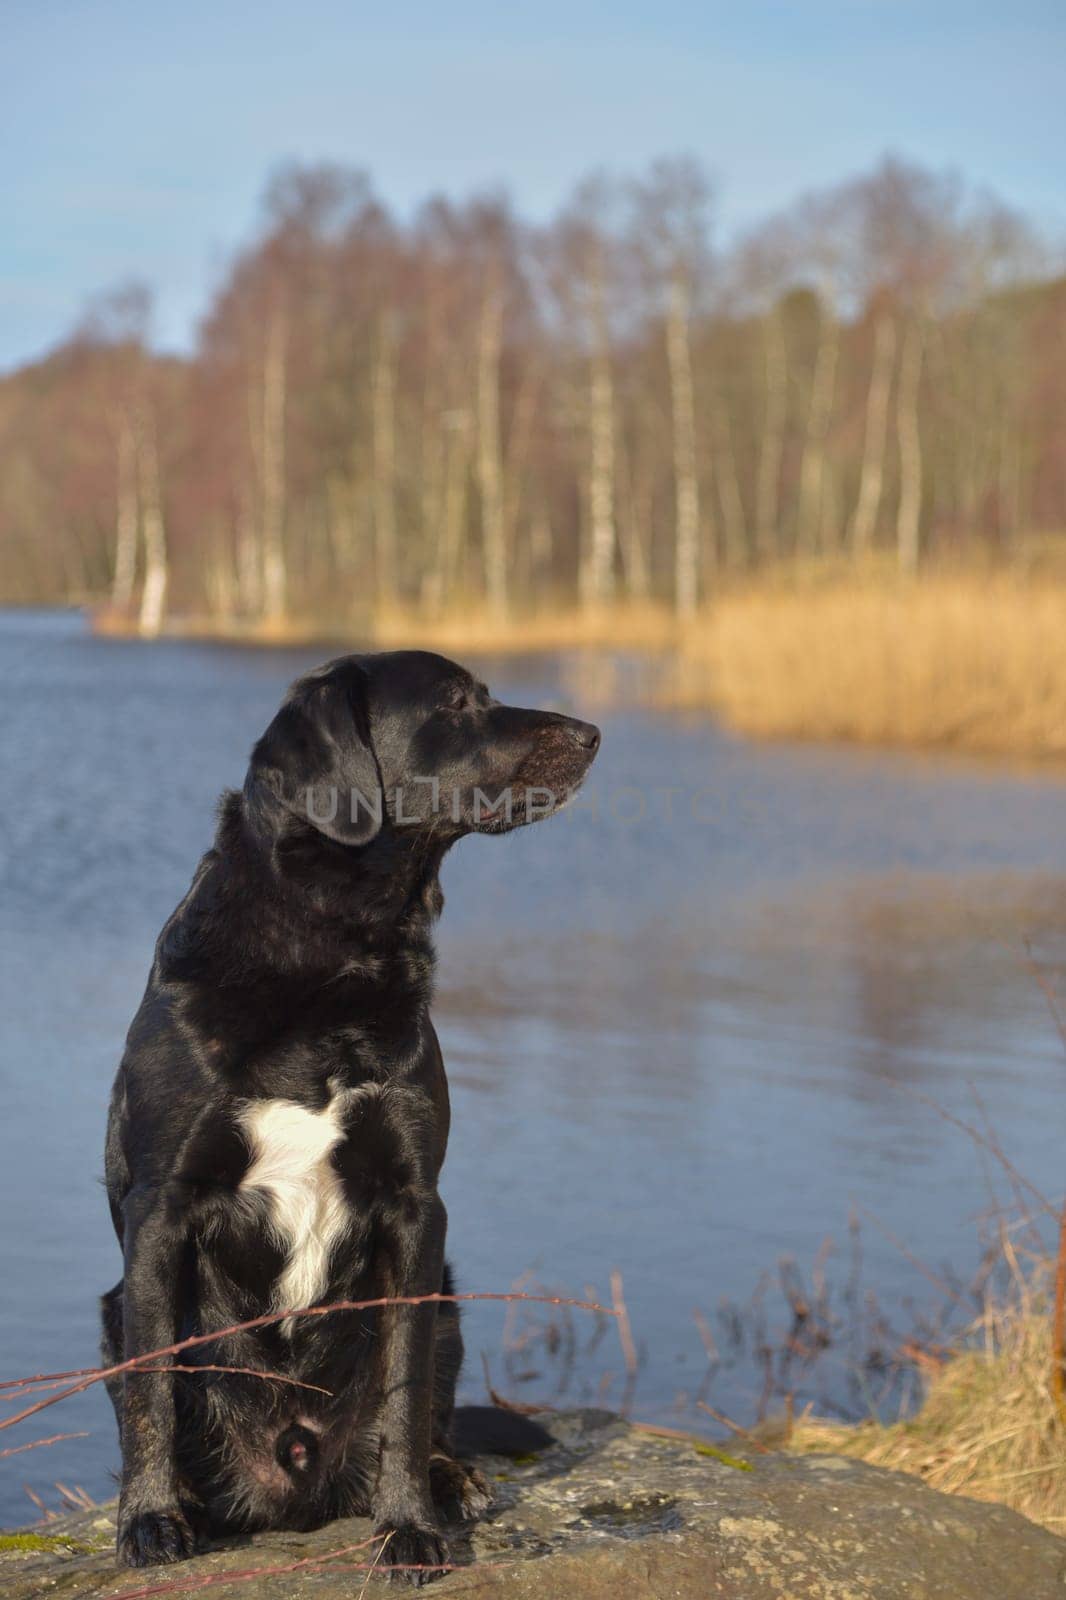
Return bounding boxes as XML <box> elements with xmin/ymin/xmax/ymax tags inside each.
<box><xmin>373</xmin><ymin>1194</ymin><xmax>448</xmax><ymax>1584</ymax></box>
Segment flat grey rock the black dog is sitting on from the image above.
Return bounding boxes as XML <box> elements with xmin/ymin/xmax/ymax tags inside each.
<box><xmin>0</xmin><ymin>1411</ymin><xmax>1066</xmax><ymax>1600</ymax></box>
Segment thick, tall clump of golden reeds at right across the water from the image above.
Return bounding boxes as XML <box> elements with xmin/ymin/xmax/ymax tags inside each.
<box><xmin>664</xmin><ymin>573</ymin><xmax>1066</xmax><ymax>757</ymax></box>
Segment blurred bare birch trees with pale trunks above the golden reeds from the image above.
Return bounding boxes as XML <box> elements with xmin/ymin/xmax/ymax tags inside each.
<box><xmin>0</xmin><ymin>150</ymin><xmax>1066</xmax><ymax>632</ymax></box>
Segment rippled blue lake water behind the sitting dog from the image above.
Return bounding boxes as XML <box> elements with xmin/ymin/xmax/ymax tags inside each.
<box><xmin>0</xmin><ymin>613</ymin><xmax>1066</xmax><ymax>1525</ymax></box>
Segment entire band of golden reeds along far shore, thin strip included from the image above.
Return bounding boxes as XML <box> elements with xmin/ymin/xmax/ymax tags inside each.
<box><xmin>91</xmin><ymin>547</ymin><xmax>1066</xmax><ymax>762</ymax></box>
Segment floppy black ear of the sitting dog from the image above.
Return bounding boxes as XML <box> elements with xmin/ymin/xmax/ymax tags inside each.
<box><xmin>245</xmin><ymin>669</ymin><xmax>384</xmax><ymax>845</ymax></box>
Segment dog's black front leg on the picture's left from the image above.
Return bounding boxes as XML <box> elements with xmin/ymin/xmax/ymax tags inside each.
<box><xmin>117</xmin><ymin>1189</ymin><xmax>195</xmax><ymax>1566</ymax></box>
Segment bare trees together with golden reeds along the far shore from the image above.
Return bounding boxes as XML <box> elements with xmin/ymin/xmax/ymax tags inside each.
<box><xmin>0</xmin><ymin>157</ymin><xmax>1066</xmax><ymax>758</ymax></box>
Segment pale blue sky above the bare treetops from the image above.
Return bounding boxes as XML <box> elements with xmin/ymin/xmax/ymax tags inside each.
<box><xmin>0</xmin><ymin>0</ymin><xmax>1066</xmax><ymax>368</ymax></box>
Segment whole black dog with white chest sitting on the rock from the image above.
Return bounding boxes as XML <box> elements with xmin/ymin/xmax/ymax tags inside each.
<box><xmin>102</xmin><ymin>651</ymin><xmax>600</xmax><ymax>1582</ymax></box>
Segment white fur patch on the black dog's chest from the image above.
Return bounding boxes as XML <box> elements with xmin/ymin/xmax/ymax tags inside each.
<box><xmin>238</xmin><ymin>1090</ymin><xmax>365</xmax><ymax>1339</ymax></box>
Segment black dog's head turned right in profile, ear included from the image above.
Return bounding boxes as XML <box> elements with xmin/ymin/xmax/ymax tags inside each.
<box><xmin>245</xmin><ymin>650</ymin><xmax>600</xmax><ymax>845</ymax></box>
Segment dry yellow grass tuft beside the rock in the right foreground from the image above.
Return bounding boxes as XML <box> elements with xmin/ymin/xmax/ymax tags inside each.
<box><xmin>791</xmin><ymin>1262</ymin><xmax>1066</xmax><ymax>1533</ymax></box>
